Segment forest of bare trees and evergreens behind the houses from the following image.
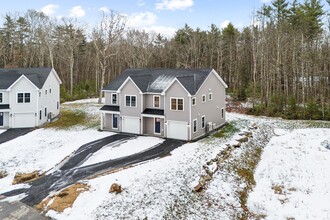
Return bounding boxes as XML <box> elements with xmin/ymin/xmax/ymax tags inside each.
<box><xmin>0</xmin><ymin>0</ymin><xmax>330</xmax><ymax>120</ymax></box>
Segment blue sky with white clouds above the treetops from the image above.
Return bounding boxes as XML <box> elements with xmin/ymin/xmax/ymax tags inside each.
<box><xmin>0</xmin><ymin>0</ymin><xmax>328</xmax><ymax>36</ymax></box>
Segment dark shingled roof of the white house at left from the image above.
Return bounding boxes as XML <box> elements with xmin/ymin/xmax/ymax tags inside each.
<box><xmin>0</xmin><ymin>67</ymin><xmax>52</xmax><ymax>89</ymax></box>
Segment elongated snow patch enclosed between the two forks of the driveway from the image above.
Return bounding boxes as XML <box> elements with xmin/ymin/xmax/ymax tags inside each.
<box><xmin>81</xmin><ymin>136</ymin><xmax>164</xmax><ymax>167</ymax></box>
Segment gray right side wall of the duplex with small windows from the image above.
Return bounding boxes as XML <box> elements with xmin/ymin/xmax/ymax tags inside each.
<box><xmin>190</xmin><ymin>73</ymin><xmax>226</xmax><ymax>139</ymax></box>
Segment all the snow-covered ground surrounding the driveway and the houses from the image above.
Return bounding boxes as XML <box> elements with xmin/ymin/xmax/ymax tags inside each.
<box><xmin>0</xmin><ymin>99</ymin><xmax>330</xmax><ymax>219</ymax></box>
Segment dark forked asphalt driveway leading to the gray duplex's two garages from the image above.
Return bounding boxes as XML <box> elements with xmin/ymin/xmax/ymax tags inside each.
<box><xmin>3</xmin><ymin>133</ymin><xmax>186</xmax><ymax>206</ymax></box>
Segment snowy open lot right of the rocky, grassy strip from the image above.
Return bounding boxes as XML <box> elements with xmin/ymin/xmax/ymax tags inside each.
<box><xmin>248</xmin><ymin>129</ymin><xmax>330</xmax><ymax>220</ymax></box>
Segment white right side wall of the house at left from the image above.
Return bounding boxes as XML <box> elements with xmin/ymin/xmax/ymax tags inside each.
<box><xmin>37</xmin><ymin>71</ymin><xmax>60</xmax><ymax>126</ymax></box>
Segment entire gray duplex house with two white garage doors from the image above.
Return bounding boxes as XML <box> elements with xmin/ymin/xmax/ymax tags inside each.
<box><xmin>101</xmin><ymin>69</ymin><xmax>227</xmax><ymax>140</ymax></box>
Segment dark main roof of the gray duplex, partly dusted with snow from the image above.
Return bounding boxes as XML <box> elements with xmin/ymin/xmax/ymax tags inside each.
<box><xmin>103</xmin><ymin>68</ymin><xmax>212</xmax><ymax>95</ymax></box>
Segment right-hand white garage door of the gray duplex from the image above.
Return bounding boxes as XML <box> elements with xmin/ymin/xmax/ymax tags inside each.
<box><xmin>167</xmin><ymin>121</ymin><xmax>188</xmax><ymax>140</ymax></box>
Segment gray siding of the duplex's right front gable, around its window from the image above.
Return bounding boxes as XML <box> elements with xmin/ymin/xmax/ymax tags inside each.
<box><xmin>164</xmin><ymin>82</ymin><xmax>190</xmax><ymax>122</ymax></box>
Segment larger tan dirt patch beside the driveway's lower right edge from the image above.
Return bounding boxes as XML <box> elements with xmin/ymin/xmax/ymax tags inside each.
<box><xmin>36</xmin><ymin>183</ymin><xmax>89</xmax><ymax>212</ymax></box>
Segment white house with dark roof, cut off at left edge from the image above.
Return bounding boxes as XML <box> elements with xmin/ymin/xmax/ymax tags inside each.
<box><xmin>0</xmin><ymin>68</ymin><xmax>62</xmax><ymax>128</ymax></box>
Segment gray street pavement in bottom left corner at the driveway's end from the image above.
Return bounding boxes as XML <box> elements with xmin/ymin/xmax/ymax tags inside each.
<box><xmin>0</xmin><ymin>195</ymin><xmax>48</xmax><ymax>220</ymax></box>
